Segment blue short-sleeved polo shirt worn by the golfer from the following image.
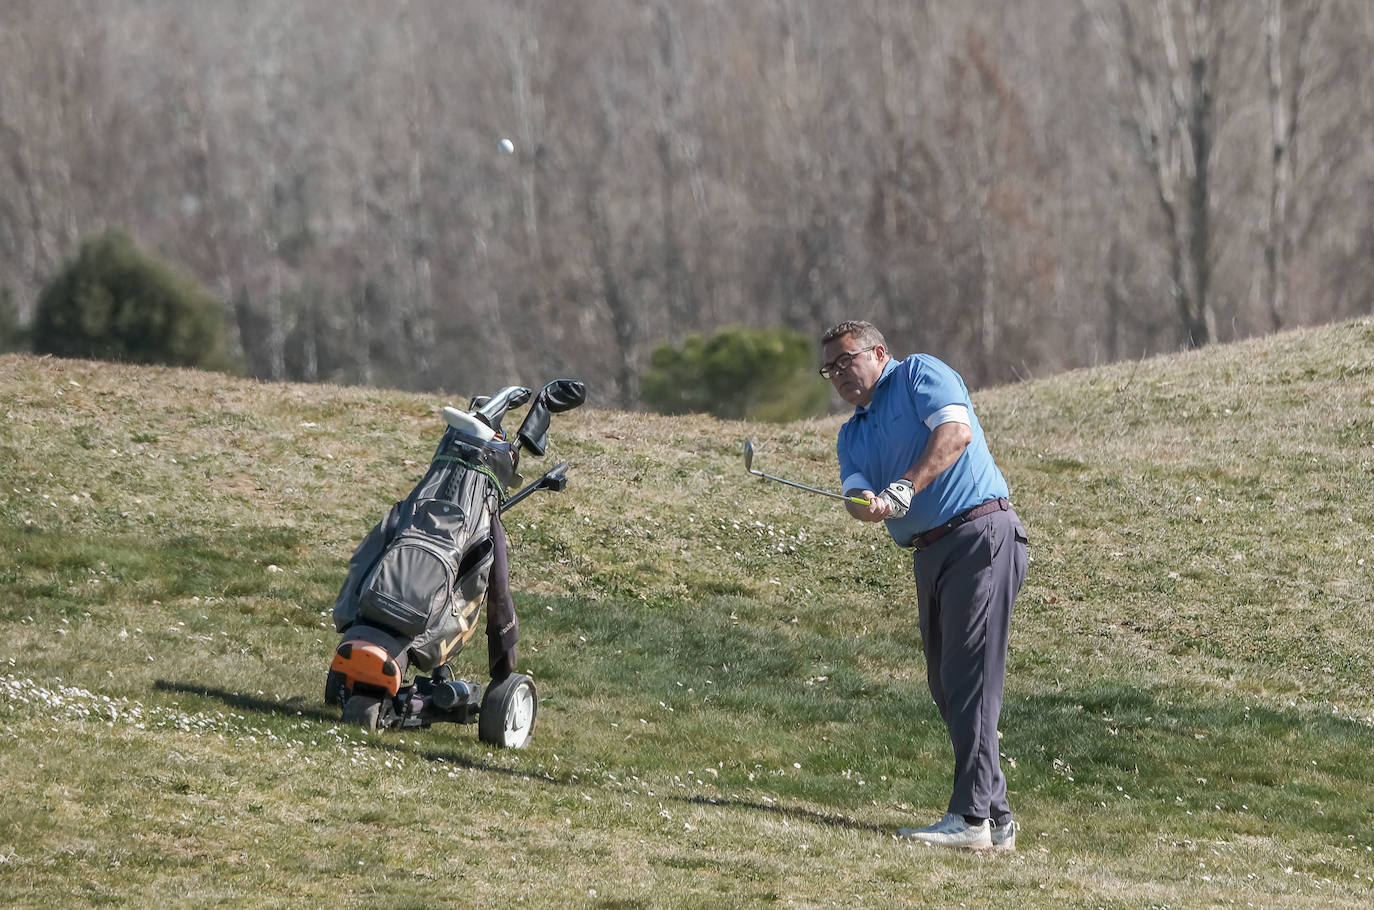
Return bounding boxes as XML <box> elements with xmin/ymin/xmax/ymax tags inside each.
<box><xmin>835</xmin><ymin>353</ymin><xmax>1009</xmax><ymax>544</ymax></box>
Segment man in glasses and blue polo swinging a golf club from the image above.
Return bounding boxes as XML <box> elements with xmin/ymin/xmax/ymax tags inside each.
<box><xmin>820</xmin><ymin>322</ymin><xmax>1026</xmax><ymax>851</ymax></box>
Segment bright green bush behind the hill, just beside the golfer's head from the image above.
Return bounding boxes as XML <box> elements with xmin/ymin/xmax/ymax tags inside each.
<box><xmin>640</xmin><ymin>327</ymin><xmax>830</xmax><ymax>423</ymax></box>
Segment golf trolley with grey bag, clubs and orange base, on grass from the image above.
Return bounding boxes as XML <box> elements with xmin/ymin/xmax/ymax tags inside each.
<box><xmin>324</xmin><ymin>379</ymin><xmax>587</xmax><ymax>749</ymax></box>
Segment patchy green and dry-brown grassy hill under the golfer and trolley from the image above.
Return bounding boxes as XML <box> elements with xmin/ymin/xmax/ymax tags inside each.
<box><xmin>0</xmin><ymin>320</ymin><xmax>1374</xmax><ymax>907</ymax></box>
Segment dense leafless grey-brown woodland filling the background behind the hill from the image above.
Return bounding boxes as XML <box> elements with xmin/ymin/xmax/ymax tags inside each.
<box><xmin>8</xmin><ymin>0</ymin><xmax>1374</xmax><ymax>398</ymax></box>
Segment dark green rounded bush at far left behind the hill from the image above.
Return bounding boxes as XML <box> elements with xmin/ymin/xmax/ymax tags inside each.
<box><xmin>32</xmin><ymin>231</ymin><xmax>227</xmax><ymax>368</ymax></box>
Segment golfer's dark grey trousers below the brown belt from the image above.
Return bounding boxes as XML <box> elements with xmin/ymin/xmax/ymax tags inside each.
<box><xmin>914</xmin><ymin>510</ymin><xmax>1026</xmax><ymax>825</ymax></box>
